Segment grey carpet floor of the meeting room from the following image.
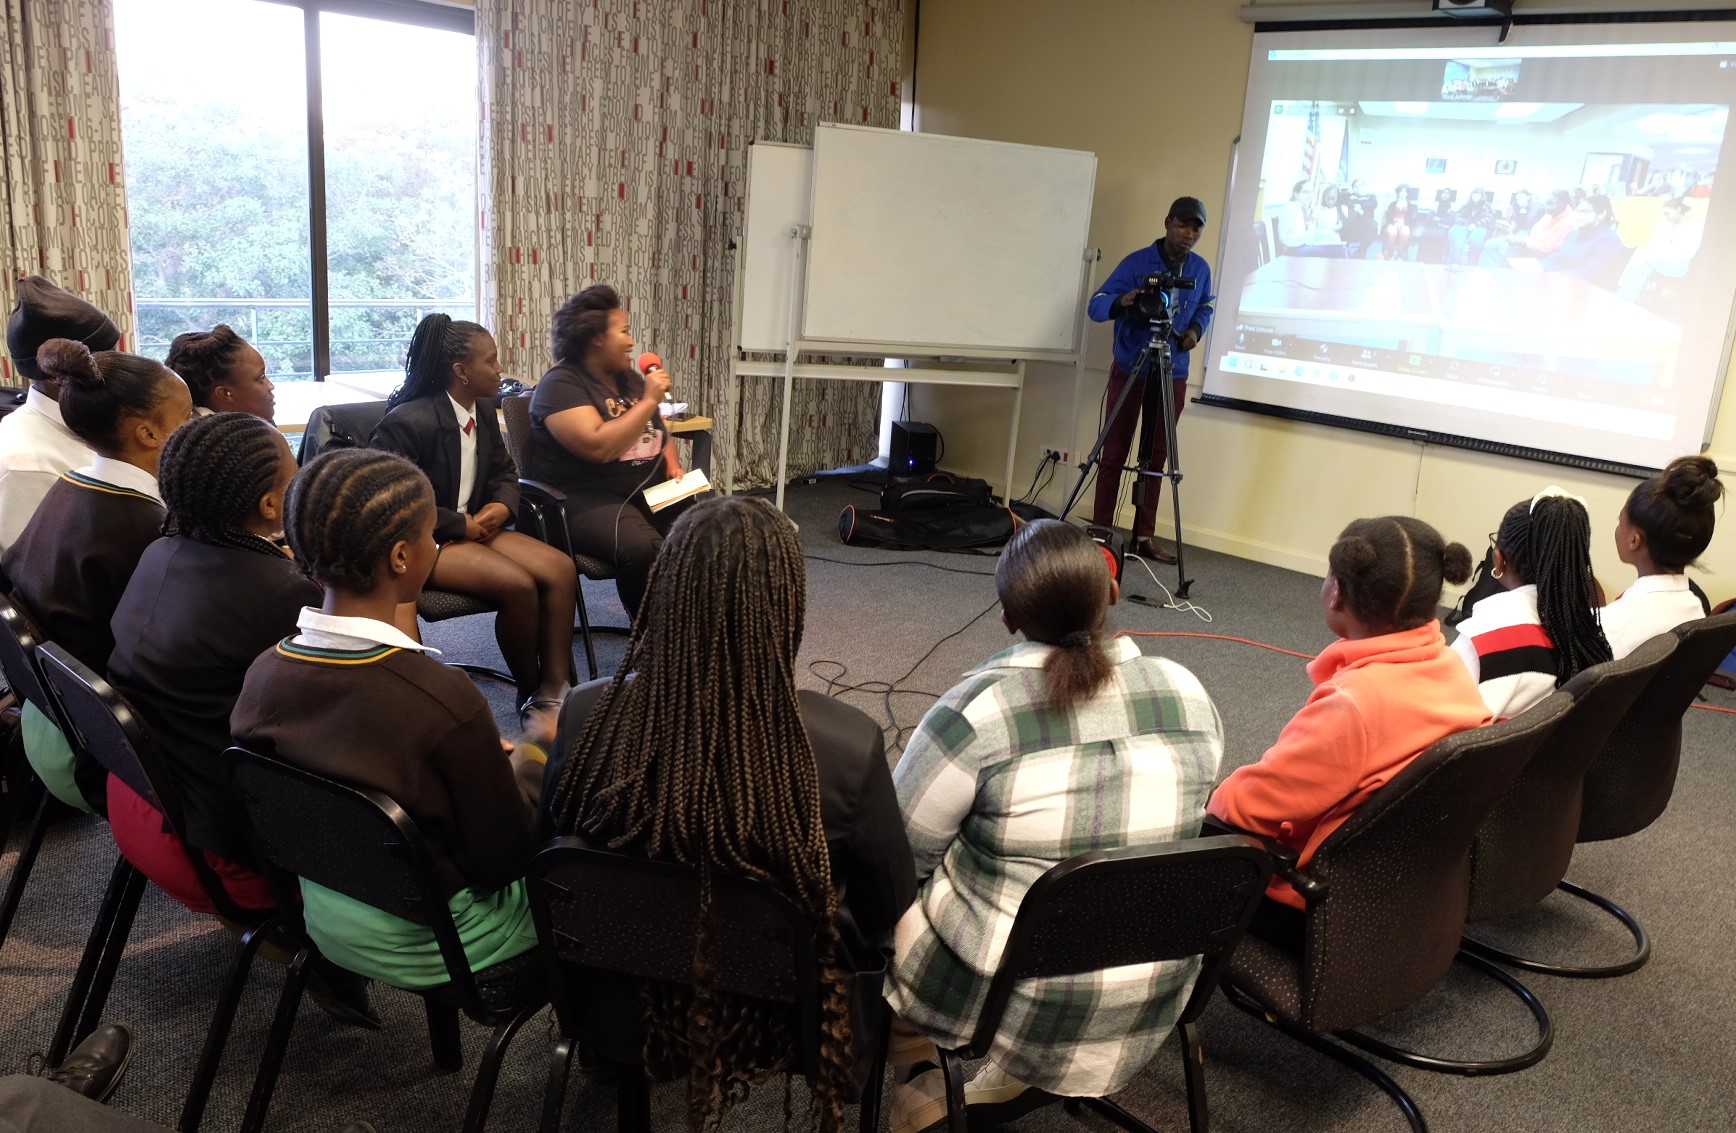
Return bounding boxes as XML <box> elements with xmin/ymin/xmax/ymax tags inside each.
<box><xmin>0</xmin><ymin>477</ymin><xmax>1736</xmax><ymax>1133</ymax></box>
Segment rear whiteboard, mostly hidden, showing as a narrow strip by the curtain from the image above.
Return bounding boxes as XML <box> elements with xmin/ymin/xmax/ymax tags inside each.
<box><xmin>736</xmin><ymin>142</ymin><xmax>812</xmax><ymax>354</ymax></box>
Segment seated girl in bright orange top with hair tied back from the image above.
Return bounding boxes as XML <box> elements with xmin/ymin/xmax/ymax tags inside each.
<box><xmin>1207</xmin><ymin>515</ymin><xmax>1491</xmax><ymax>951</ymax></box>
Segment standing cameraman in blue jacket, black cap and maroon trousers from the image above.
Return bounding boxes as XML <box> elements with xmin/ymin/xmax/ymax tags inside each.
<box><xmin>1088</xmin><ymin>196</ymin><xmax>1213</xmax><ymax>562</ymax></box>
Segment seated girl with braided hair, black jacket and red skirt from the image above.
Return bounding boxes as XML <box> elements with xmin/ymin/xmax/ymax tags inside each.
<box><xmin>108</xmin><ymin>413</ymin><xmax>319</xmax><ymax>913</ymax></box>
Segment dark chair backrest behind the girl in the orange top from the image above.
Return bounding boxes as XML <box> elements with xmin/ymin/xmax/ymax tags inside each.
<box><xmin>1300</xmin><ymin>696</ymin><xmax>1573</xmax><ymax>1031</ymax></box>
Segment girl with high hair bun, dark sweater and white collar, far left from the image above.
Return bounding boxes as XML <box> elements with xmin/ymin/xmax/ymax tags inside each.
<box><xmin>3</xmin><ymin>338</ymin><xmax>193</xmax><ymax>810</ymax></box>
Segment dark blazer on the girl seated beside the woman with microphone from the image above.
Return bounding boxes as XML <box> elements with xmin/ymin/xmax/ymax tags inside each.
<box><xmin>370</xmin><ymin>390</ymin><xmax>519</xmax><ymax>543</ymax></box>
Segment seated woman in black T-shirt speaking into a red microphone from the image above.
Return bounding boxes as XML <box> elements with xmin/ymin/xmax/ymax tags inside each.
<box><xmin>526</xmin><ymin>283</ymin><xmax>686</xmax><ymax>616</ymax></box>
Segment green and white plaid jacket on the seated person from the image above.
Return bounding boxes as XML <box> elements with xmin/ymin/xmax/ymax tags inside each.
<box><xmin>887</xmin><ymin>637</ymin><xmax>1224</xmax><ymax>1097</ymax></box>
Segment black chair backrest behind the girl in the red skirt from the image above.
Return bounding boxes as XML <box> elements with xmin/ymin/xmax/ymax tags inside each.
<box><xmin>38</xmin><ymin>644</ymin><xmax>259</xmax><ymax>925</ymax></box>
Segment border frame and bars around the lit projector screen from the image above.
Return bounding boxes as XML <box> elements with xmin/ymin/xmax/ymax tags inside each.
<box><xmin>1193</xmin><ymin>16</ymin><xmax>1736</xmax><ymax>479</ymax></box>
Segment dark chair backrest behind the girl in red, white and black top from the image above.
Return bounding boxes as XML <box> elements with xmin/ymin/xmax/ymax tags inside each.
<box><xmin>1465</xmin><ymin>633</ymin><xmax>1675</xmax><ymax>921</ymax></box>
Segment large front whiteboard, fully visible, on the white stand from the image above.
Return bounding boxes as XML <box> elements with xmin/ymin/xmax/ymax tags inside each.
<box><xmin>802</xmin><ymin>125</ymin><xmax>1097</xmax><ymax>357</ymax></box>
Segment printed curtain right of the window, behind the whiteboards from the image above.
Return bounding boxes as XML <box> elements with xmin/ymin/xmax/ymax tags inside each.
<box><xmin>476</xmin><ymin>0</ymin><xmax>906</xmax><ymax>486</ymax></box>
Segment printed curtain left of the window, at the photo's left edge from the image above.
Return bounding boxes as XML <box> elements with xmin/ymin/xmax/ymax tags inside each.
<box><xmin>0</xmin><ymin>0</ymin><xmax>132</xmax><ymax>385</ymax></box>
